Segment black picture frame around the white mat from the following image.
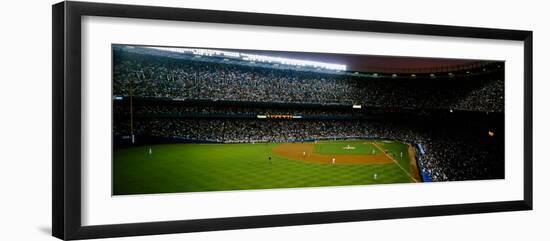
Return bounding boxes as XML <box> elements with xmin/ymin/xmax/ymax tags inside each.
<box><xmin>52</xmin><ymin>2</ymin><xmax>533</xmax><ymax>240</ymax></box>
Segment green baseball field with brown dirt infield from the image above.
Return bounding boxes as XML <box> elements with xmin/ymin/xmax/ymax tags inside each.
<box><xmin>113</xmin><ymin>140</ymin><xmax>420</xmax><ymax>195</ymax></box>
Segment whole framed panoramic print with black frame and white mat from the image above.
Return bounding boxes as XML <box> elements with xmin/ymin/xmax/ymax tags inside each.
<box><xmin>52</xmin><ymin>1</ymin><xmax>532</xmax><ymax>239</ymax></box>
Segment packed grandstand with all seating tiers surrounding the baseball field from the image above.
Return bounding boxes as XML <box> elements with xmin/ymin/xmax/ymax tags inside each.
<box><xmin>113</xmin><ymin>45</ymin><xmax>504</xmax><ymax>181</ymax></box>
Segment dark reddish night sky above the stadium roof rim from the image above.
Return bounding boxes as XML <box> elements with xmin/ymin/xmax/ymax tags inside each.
<box><xmin>233</xmin><ymin>50</ymin><xmax>498</xmax><ymax>73</ymax></box>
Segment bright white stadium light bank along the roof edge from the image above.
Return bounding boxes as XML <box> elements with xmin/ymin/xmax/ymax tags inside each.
<box><xmin>148</xmin><ymin>47</ymin><xmax>346</xmax><ymax>71</ymax></box>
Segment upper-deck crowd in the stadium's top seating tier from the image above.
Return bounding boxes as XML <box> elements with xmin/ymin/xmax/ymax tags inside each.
<box><xmin>113</xmin><ymin>49</ymin><xmax>504</xmax><ymax>112</ymax></box>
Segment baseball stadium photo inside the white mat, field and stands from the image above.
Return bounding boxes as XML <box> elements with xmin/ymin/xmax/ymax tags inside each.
<box><xmin>112</xmin><ymin>44</ymin><xmax>504</xmax><ymax>195</ymax></box>
